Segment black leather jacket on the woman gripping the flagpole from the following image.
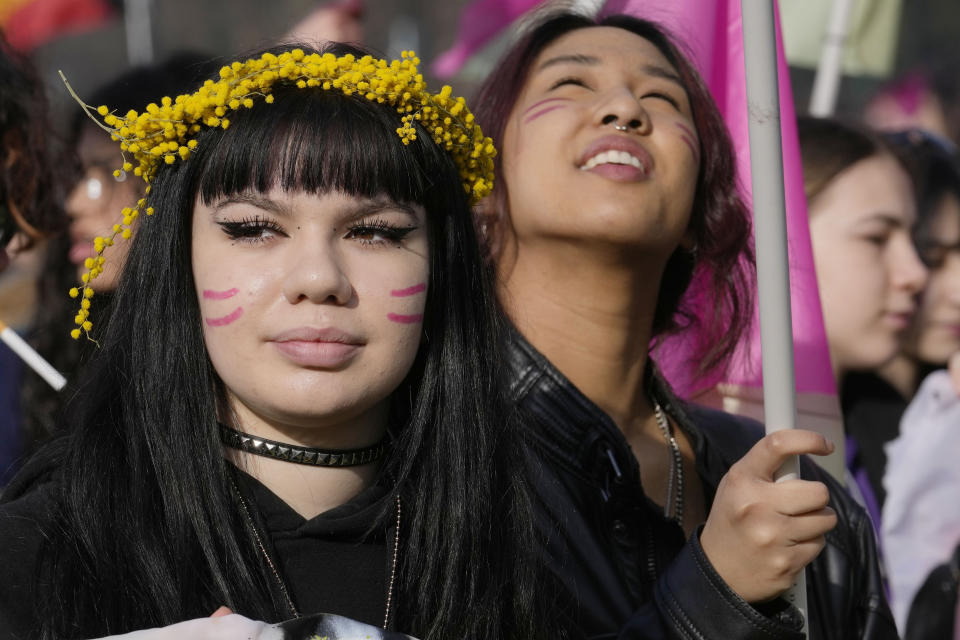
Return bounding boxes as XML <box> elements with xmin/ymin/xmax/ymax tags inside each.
<box><xmin>507</xmin><ymin>333</ymin><xmax>897</xmax><ymax>640</ymax></box>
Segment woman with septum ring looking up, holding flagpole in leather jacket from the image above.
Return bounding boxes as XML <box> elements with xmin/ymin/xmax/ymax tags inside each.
<box><xmin>477</xmin><ymin>14</ymin><xmax>896</xmax><ymax>639</ymax></box>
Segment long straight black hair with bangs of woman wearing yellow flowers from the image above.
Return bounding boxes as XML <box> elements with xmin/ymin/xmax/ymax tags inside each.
<box><xmin>20</xmin><ymin>45</ymin><xmax>555</xmax><ymax>640</ymax></box>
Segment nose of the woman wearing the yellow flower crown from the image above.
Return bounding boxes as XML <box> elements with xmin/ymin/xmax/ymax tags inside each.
<box><xmin>282</xmin><ymin>234</ymin><xmax>354</xmax><ymax>305</ymax></box>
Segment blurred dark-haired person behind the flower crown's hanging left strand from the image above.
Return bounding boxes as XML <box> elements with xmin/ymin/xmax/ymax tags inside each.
<box><xmin>6</xmin><ymin>53</ymin><xmax>212</xmax><ymax>485</ymax></box>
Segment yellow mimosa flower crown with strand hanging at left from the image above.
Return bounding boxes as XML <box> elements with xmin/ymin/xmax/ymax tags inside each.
<box><xmin>67</xmin><ymin>49</ymin><xmax>497</xmax><ymax>338</ymax></box>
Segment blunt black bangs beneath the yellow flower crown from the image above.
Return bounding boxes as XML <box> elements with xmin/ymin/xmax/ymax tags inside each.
<box><xmin>191</xmin><ymin>87</ymin><xmax>446</xmax><ymax>204</ymax></box>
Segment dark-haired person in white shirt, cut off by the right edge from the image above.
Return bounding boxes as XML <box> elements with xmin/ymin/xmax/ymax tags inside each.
<box><xmin>872</xmin><ymin>130</ymin><xmax>960</xmax><ymax>640</ymax></box>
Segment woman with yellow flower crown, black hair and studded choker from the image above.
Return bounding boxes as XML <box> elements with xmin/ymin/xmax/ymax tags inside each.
<box><xmin>0</xmin><ymin>45</ymin><xmax>555</xmax><ymax>640</ymax></box>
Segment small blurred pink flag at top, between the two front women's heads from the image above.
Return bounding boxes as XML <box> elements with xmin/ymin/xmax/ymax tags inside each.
<box><xmin>432</xmin><ymin>0</ymin><xmax>544</xmax><ymax>78</ymax></box>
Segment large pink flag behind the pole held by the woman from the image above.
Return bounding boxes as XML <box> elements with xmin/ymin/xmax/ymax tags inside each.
<box><xmin>602</xmin><ymin>0</ymin><xmax>836</xmax><ymax>396</ymax></box>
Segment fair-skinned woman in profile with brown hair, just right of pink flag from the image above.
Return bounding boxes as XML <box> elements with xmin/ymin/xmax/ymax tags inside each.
<box><xmin>798</xmin><ymin>117</ymin><xmax>927</xmax><ymax>533</ymax></box>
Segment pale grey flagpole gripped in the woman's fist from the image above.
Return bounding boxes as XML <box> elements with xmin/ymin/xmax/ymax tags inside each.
<box><xmin>741</xmin><ymin>0</ymin><xmax>807</xmax><ymax>633</ymax></box>
